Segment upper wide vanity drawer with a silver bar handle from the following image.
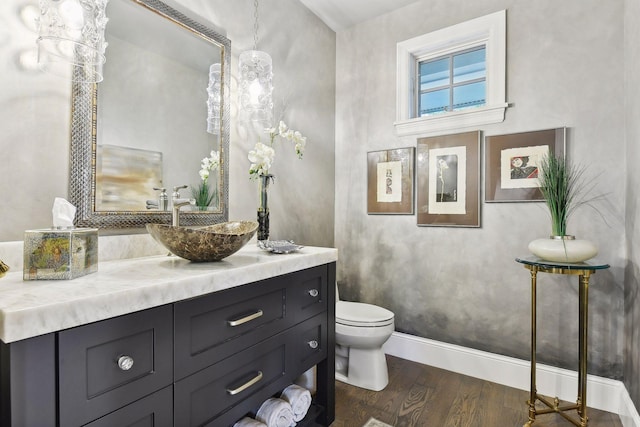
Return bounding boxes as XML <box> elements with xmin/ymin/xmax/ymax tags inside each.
<box><xmin>175</xmin><ymin>278</ymin><xmax>292</xmax><ymax>379</ymax></box>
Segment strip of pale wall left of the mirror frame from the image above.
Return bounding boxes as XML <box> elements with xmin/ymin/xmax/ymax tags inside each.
<box><xmin>0</xmin><ymin>0</ymin><xmax>71</xmax><ymax>241</ymax></box>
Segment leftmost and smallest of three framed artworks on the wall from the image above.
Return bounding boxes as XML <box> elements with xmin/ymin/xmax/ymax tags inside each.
<box><xmin>367</xmin><ymin>147</ymin><xmax>415</xmax><ymax>214</ymax></box>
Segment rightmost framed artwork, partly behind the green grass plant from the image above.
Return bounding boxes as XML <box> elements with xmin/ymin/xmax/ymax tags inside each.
<box><xmin>484</xmin><ymin>128</ymin><xmax>567</xmax><ymax>202</ymax></box>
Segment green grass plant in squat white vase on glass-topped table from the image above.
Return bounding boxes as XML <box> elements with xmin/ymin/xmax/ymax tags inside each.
<box><xmin>529</xmin><ymin>151</ymin><xmax>598</xmax><ymax>262</ymax></box>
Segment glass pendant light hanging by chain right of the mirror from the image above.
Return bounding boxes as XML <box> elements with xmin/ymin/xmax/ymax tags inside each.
<box><xmin>238</xmin><ymin>0</ymin><xmax>273</xmax><ymax>125</ymax></box>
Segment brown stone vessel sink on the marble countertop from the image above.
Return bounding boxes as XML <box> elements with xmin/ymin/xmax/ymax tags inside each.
<box><xmin>146</xmin><ymin>221</ymin><xmax>258</xmax><ymax>262</ymax></box>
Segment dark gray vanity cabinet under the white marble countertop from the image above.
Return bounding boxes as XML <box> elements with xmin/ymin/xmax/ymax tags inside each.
<box><xmin>0</xmin><ymin>263</ymin><xmax>335</xmax><ymax>427</ymax></box>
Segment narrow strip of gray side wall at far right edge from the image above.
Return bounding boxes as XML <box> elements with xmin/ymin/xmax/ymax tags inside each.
<box><xmin>624</xmin><ymin>0</ymin><xmax>640</xmax><ymax>408</ymax></box>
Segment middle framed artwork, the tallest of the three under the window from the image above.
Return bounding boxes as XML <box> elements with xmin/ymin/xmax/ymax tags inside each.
<box><xmin>417</xmin><ymin>131</ymin><xmax>480</xmax><ymax>227</ymax></box>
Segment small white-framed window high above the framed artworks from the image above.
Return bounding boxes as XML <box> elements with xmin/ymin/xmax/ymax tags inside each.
<box><xmin>395</xmin><ymin>10</ymin><xmax>507</xmax><ymax>136</ymax></box>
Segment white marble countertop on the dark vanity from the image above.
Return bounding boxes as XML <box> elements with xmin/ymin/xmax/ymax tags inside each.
<box><xmin>0</xmin><ymin>243</ymin><xmax>338</xmax><ymax>343</ymax></box>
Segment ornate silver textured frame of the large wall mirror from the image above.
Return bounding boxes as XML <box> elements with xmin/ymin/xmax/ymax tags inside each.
<box><xmin>69</xmin><ymin>0</ymin><xmax>231</xmax><ymax>229</ymax></box>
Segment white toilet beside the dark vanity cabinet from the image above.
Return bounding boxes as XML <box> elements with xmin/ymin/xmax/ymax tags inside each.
<box><xmin>336</xmin><ymin>290</ymin><xmax>394</xmax><ymax>391</ymax></box>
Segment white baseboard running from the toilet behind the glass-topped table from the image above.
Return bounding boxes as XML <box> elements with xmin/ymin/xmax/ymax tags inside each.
<box><xmin>383</xmin><ymin>332</ymin><xmax>640</xmax><ymax>427</ymax></box>
